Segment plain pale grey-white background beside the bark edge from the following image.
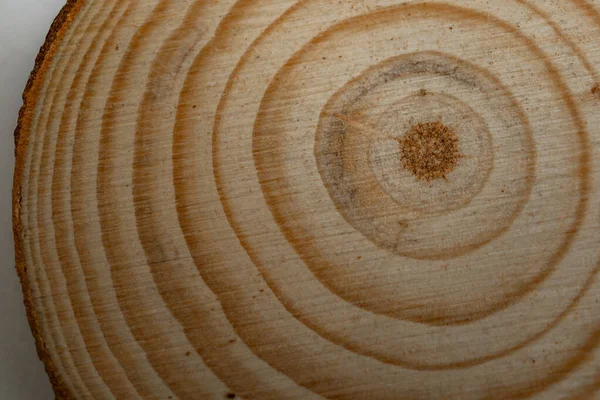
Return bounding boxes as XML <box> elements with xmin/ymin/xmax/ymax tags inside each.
<box><xmin>0</xmin><ymin>0</ymin><xmax>65</xmax><ymax>400</ymax></box>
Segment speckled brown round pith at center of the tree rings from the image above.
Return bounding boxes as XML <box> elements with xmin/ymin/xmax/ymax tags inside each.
<box><xmin>398</xmin><ymin>121</ymin><xmax>462</xmax><ymax>182</ymax></box>
